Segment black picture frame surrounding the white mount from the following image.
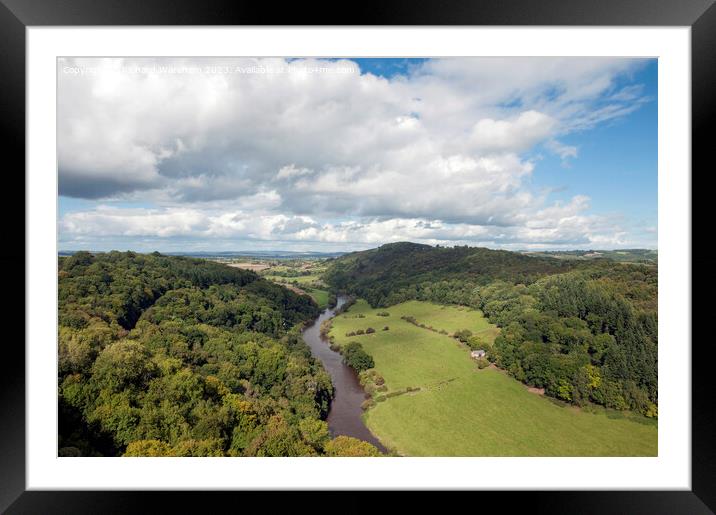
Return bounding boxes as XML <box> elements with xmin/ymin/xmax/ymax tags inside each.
<box><xmin>0</xmin><ymin>0</ymin><xmax>716</xmax><ymax>514</ymax></box>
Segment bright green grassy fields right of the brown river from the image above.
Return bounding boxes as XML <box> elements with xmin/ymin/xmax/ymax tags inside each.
<box><xmin>331</xmin><ymin>301</ymin><xmax>657</xmax><ymax>456</ymax></box>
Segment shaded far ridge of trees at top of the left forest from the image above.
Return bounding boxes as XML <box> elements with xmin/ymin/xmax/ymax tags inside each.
<box><xmin>58</xmin><ymin>252</ymin><xmax>318</xmax><ymax>329</ymax></box>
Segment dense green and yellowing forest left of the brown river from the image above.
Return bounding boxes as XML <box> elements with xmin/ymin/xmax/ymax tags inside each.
<box><xmin>58</xmin><ymin>252</ymin><xmax>378</xmax><ymax>456</ymax></box>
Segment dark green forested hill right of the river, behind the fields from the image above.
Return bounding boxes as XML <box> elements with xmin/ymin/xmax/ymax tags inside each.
<box><xmin>323</xmin><ymin>243</ymin><xmax>658</xmax><ymax>417</ymax></box>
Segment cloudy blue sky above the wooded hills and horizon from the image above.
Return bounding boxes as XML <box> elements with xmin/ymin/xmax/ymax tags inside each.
<box><xmin>57</xmin><ymin>57</ymin><xmax>657</xmax><ymax>252</ymax></box>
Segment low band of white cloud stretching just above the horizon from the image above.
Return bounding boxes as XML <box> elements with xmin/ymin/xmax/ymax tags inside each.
<box><xmin>60</xmin><ymin>196</ymin><xmax>627</xmax><ymax>249</ymax></box>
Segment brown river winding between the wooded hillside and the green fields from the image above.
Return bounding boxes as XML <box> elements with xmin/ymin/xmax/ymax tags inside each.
<box><xmin>303</xmin><ymin>296</ymin><xmax>387</xmax><ymax>452</ymax></box>
